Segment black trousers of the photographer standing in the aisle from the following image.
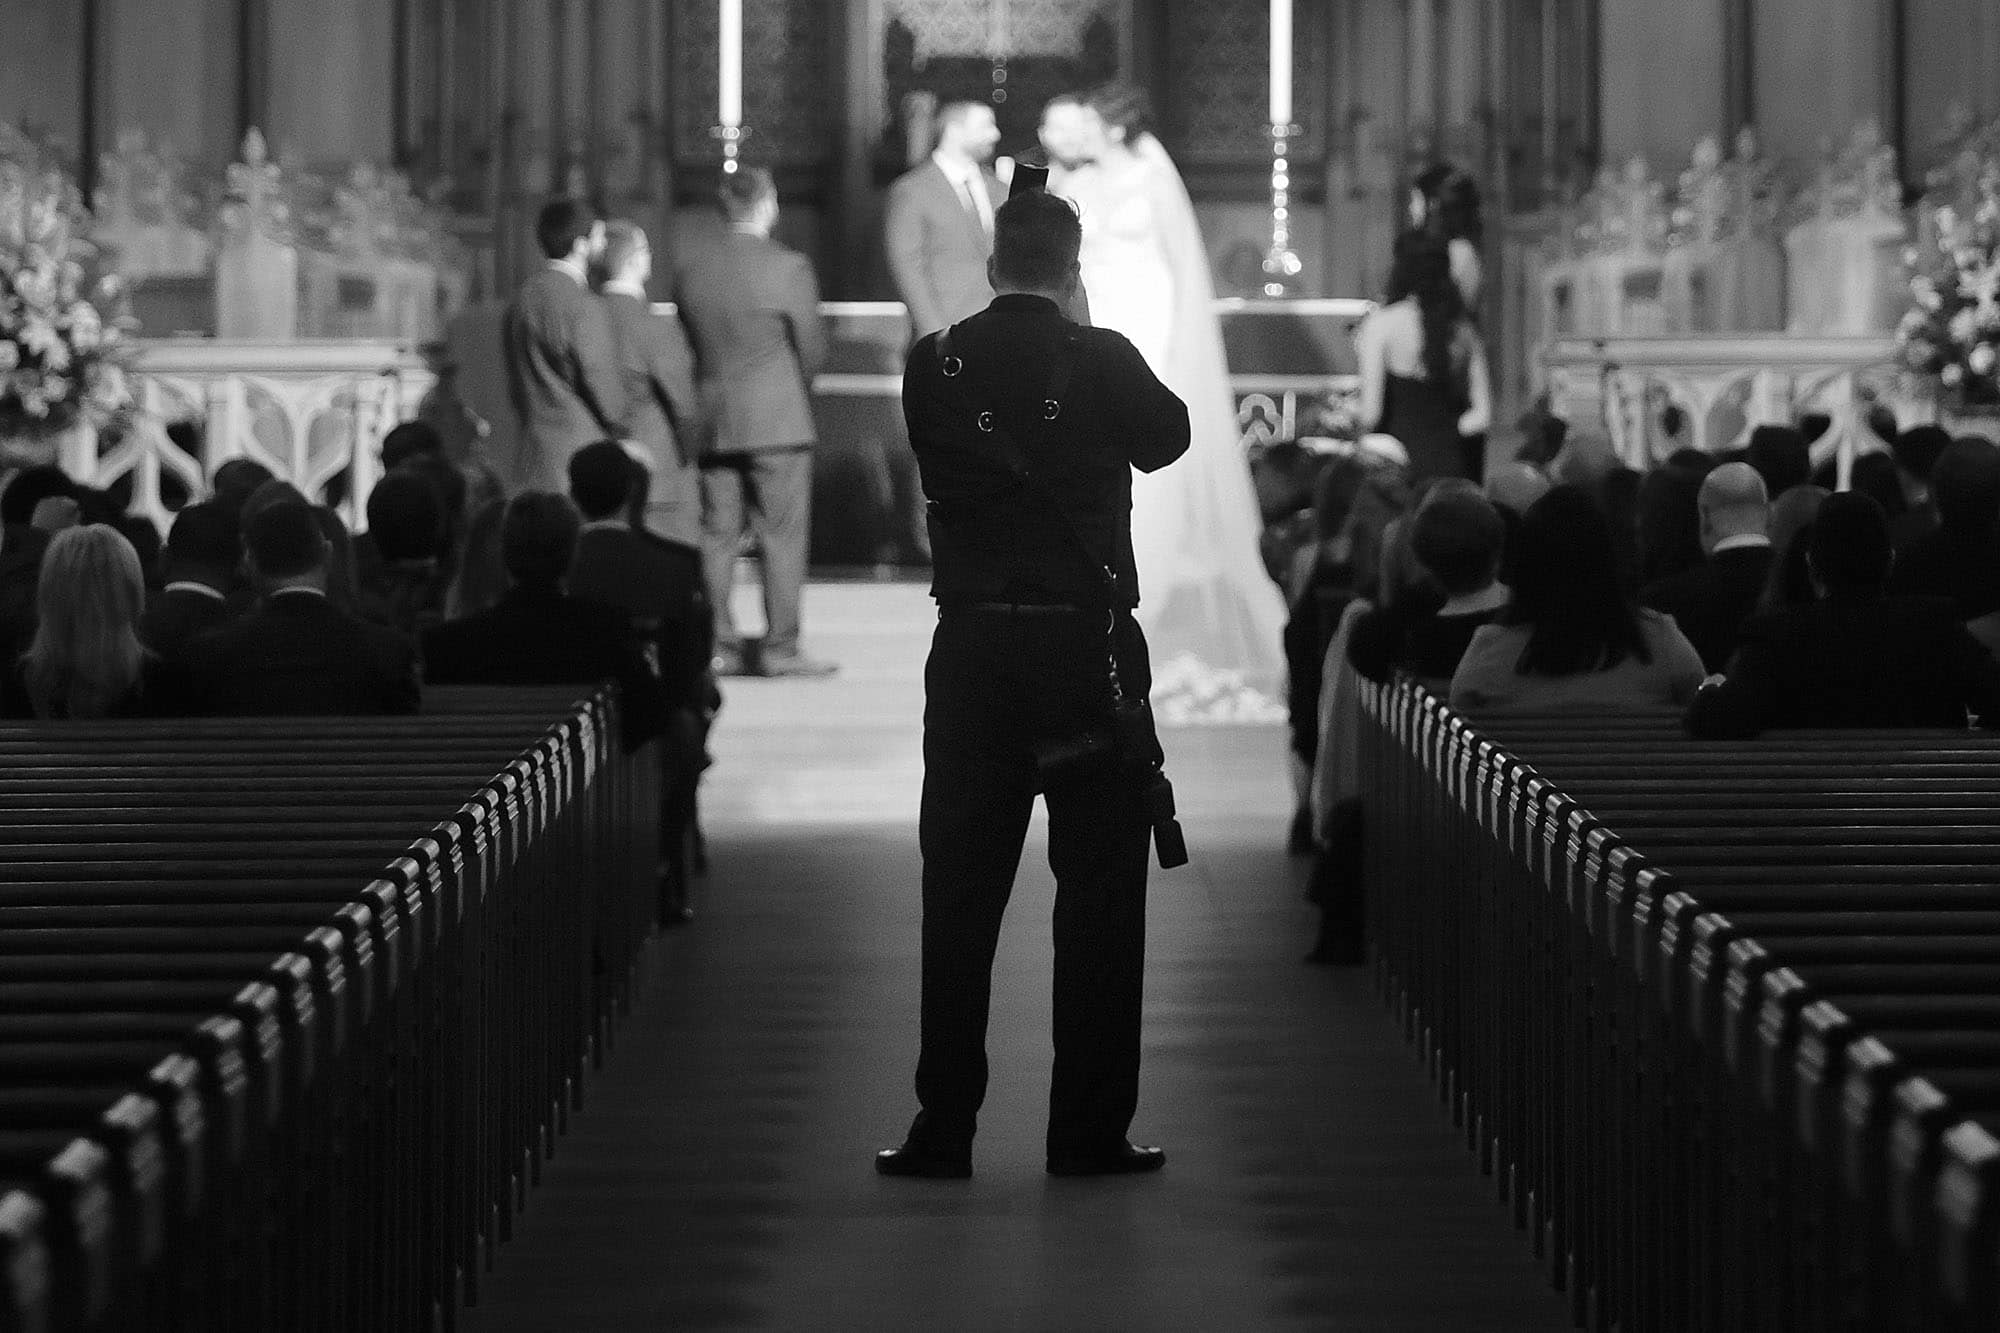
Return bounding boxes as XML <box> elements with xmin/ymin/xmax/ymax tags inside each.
<box><xmin>912</xmin><ymin>608</ymin><xmax>1152</xmax><ymax>1153</ymax></box>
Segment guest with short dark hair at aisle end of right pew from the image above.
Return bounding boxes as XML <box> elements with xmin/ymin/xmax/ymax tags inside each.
<box><xmin>1348</xmin><ymin>486</ymin><xmax>1508</xmax><ymax>693</ymax></box>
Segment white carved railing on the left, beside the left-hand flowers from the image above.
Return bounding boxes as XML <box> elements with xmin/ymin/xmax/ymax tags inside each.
<box><xmin>60</xmin><ymin>338</ymin><xmax>432</xmax><ymax>528</ymax></box>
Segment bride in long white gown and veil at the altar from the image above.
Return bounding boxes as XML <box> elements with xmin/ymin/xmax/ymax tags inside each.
<box><xmin>1042</xmin><ymin>88</ymin><xmax>1286</xmax><ymax>721</ymax></box>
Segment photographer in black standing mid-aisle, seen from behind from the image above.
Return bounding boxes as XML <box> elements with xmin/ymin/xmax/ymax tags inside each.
<box><xmin>876</xmin><ymin>190</ymin><xmax>1188</xmax><ymax>1177</ymax></box>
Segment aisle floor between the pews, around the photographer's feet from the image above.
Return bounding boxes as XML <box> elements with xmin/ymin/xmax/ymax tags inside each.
<box><xmin>466</xmin><ymin>584</ymin><xmax>1566</xmax><ymax>1333</ymax></box>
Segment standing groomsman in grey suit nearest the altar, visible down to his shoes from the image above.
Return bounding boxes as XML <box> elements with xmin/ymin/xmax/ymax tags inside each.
<box><xmin>674</xmin><ymin>166</ymin><xmax>834</xmax><ymax>677</ymax></box>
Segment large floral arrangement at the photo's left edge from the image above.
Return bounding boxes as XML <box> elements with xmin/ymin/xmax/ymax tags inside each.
<box><xmin>0</xmin><ymin>134</ymin><xmax>130</xmax><ymax>438</ymax></box>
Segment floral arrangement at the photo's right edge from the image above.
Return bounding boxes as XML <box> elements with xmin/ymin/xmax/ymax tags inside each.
<box><xmin>1896</xmin><ymin>162</ymin><xmax>2000</xmax><ymax>406</ymax></box>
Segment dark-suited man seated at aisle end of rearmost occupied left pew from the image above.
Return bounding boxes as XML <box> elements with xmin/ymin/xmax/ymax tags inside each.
<box><xmin>424</xmin><ymin>490</ymin><xmax>666</xmax><ymax>749</ymax></box>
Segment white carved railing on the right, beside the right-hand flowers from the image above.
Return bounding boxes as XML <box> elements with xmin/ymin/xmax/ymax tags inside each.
<box><xmin>1542</xmin><ymin>334</ymin><xmax>1936</xmax><ymax>486</ymax></box>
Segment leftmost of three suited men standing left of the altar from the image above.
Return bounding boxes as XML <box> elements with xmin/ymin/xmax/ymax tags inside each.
<box><xmin>500</xmin><ymin>198</ymin><xmax>626</xmax><ymax>490</ymax></box>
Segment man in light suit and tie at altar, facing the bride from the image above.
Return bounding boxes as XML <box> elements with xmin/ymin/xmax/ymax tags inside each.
<box><xmin>882</xmin><ymin>102</ymin><xmax>1006</xmax><ymax>338</ymax></box>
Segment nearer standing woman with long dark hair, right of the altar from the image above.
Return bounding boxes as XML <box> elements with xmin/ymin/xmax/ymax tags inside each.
<box><xmin>1354</xmin><ymin>230</ymin><xmax>1492</xmax><ymax>488</ymax></box>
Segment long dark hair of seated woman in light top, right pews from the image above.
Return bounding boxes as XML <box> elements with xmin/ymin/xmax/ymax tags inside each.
<box><xmin>1504</xmin><ymin>486</ymin><xmax>1652</xmax><ymax>677</ymax></box>
